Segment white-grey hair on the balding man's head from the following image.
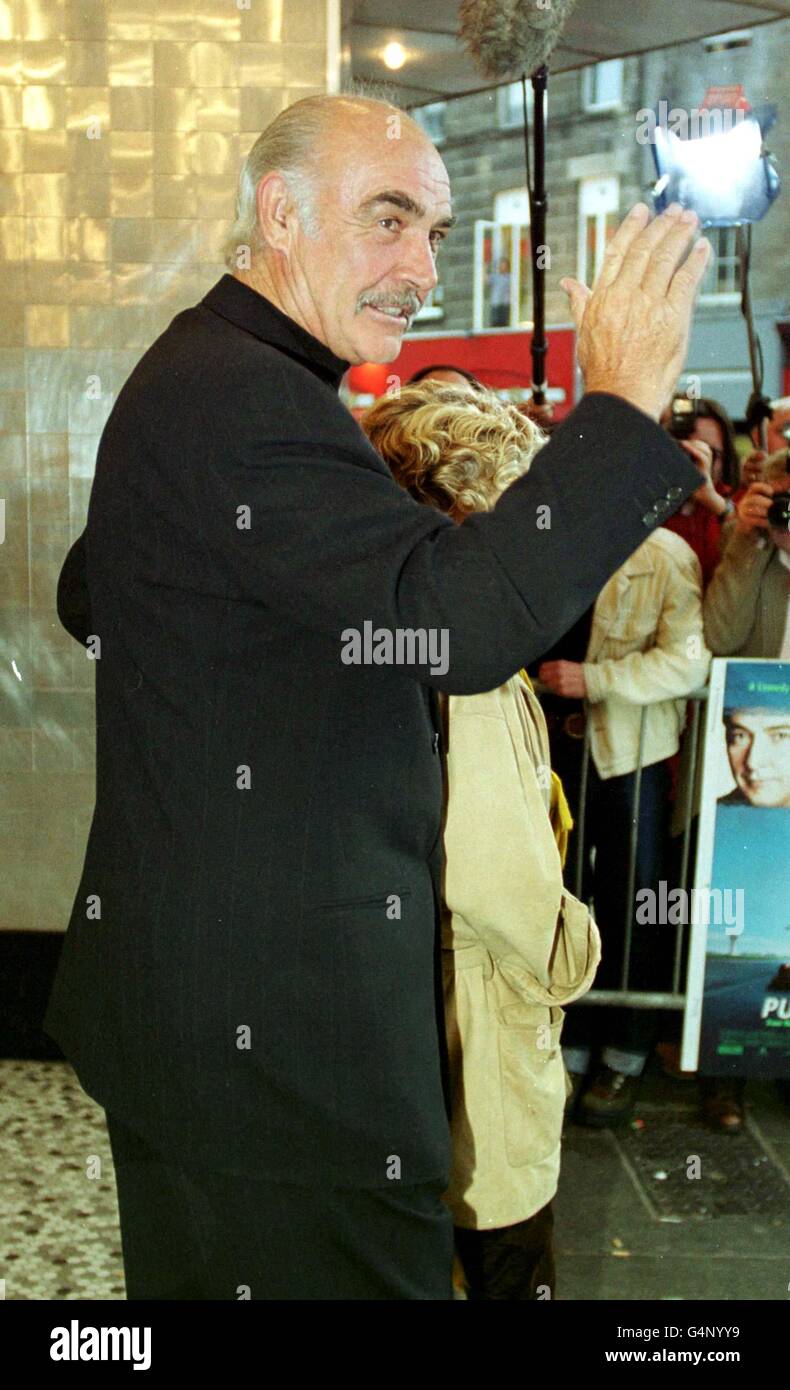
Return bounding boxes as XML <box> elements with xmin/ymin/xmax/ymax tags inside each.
<box><xmin>224</xmin><ymin>92</ymin><xmax>409</xmax><ymax>270</ymax></box>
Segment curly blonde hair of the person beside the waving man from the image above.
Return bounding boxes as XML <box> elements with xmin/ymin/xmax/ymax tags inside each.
<box><xmin>360</xmin><ymin>378</ymin><xmax>545</xmax><ymax>513</ymax></box>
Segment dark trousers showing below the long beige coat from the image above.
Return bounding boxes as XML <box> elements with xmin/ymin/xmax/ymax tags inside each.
<box><xmin>455</xmin><ymin>1202</ymin><xmax>555</xmax><ymax>1302</ymax></box>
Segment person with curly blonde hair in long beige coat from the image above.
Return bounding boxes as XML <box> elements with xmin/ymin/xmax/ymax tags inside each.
<box><xmin>360</xmin><ymin>379</ymin><xmax>599</xmax><ymax>1300</ymax></box>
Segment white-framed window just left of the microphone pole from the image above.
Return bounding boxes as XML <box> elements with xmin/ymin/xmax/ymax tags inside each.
<box><xmin>473</xmin><ymin>188</ymin><xmax>530</xmax><ymax>332</ymax></box>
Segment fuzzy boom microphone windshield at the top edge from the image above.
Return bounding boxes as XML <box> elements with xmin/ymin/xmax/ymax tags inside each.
<box><xmin>458</xmin><ymin>0</ymin><xmax>576</xmax><ymax>78</ymax></box>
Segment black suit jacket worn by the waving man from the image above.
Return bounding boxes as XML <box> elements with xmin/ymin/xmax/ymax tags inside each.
<box><xmin>46</xmin><ymin>275</ymin><xmax>700</xmax><ymax>1186</ymax></box>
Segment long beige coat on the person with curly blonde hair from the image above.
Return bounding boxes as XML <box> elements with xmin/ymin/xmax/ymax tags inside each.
<box><xmin>442</xmin><ymin>676</ymin><xmax>601</xmax><ymax>1229</ymax></box>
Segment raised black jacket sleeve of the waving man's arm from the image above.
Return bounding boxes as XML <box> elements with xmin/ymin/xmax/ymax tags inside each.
<box><xmin>200</xmin><ymin>354</ymin><xmax>700</xmax><ymax>694</ymax></box>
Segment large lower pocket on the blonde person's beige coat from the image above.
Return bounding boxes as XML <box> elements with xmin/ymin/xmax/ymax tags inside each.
<box><xmin>499</xmin><ymin>1004</ymin><xmax>566</xmax><ymax>1168</ymax></box>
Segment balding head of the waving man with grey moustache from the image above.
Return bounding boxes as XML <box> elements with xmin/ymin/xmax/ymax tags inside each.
<box><xmin>228</xmin><ymin>96</ymin><xmax>453</xmax><ymax>363</ymax></box>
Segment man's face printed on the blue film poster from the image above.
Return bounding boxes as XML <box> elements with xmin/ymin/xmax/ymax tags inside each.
<box><xmin>725</xmin><ymin>709</ymin><xmax>790</xmax><ymax>806</ymax></box>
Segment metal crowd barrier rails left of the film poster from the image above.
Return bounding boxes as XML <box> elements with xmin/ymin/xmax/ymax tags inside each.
<box><xmin>535</xmin><ymin>681</ymin><xmax>708</xmax><ymax>1009</ymax></box>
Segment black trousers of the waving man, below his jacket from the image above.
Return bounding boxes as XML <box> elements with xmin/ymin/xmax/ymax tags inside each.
<box><xmin>107</xmin><ymin>1113</ymin><xmax>453</xmax><ymax>1300</ymax></box>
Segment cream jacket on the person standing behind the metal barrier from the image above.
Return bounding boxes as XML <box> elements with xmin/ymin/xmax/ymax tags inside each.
<box><xmin>583</xmin><ymin>527</ymin><xmax>711</xmax><ymax>778</ymax></box>
